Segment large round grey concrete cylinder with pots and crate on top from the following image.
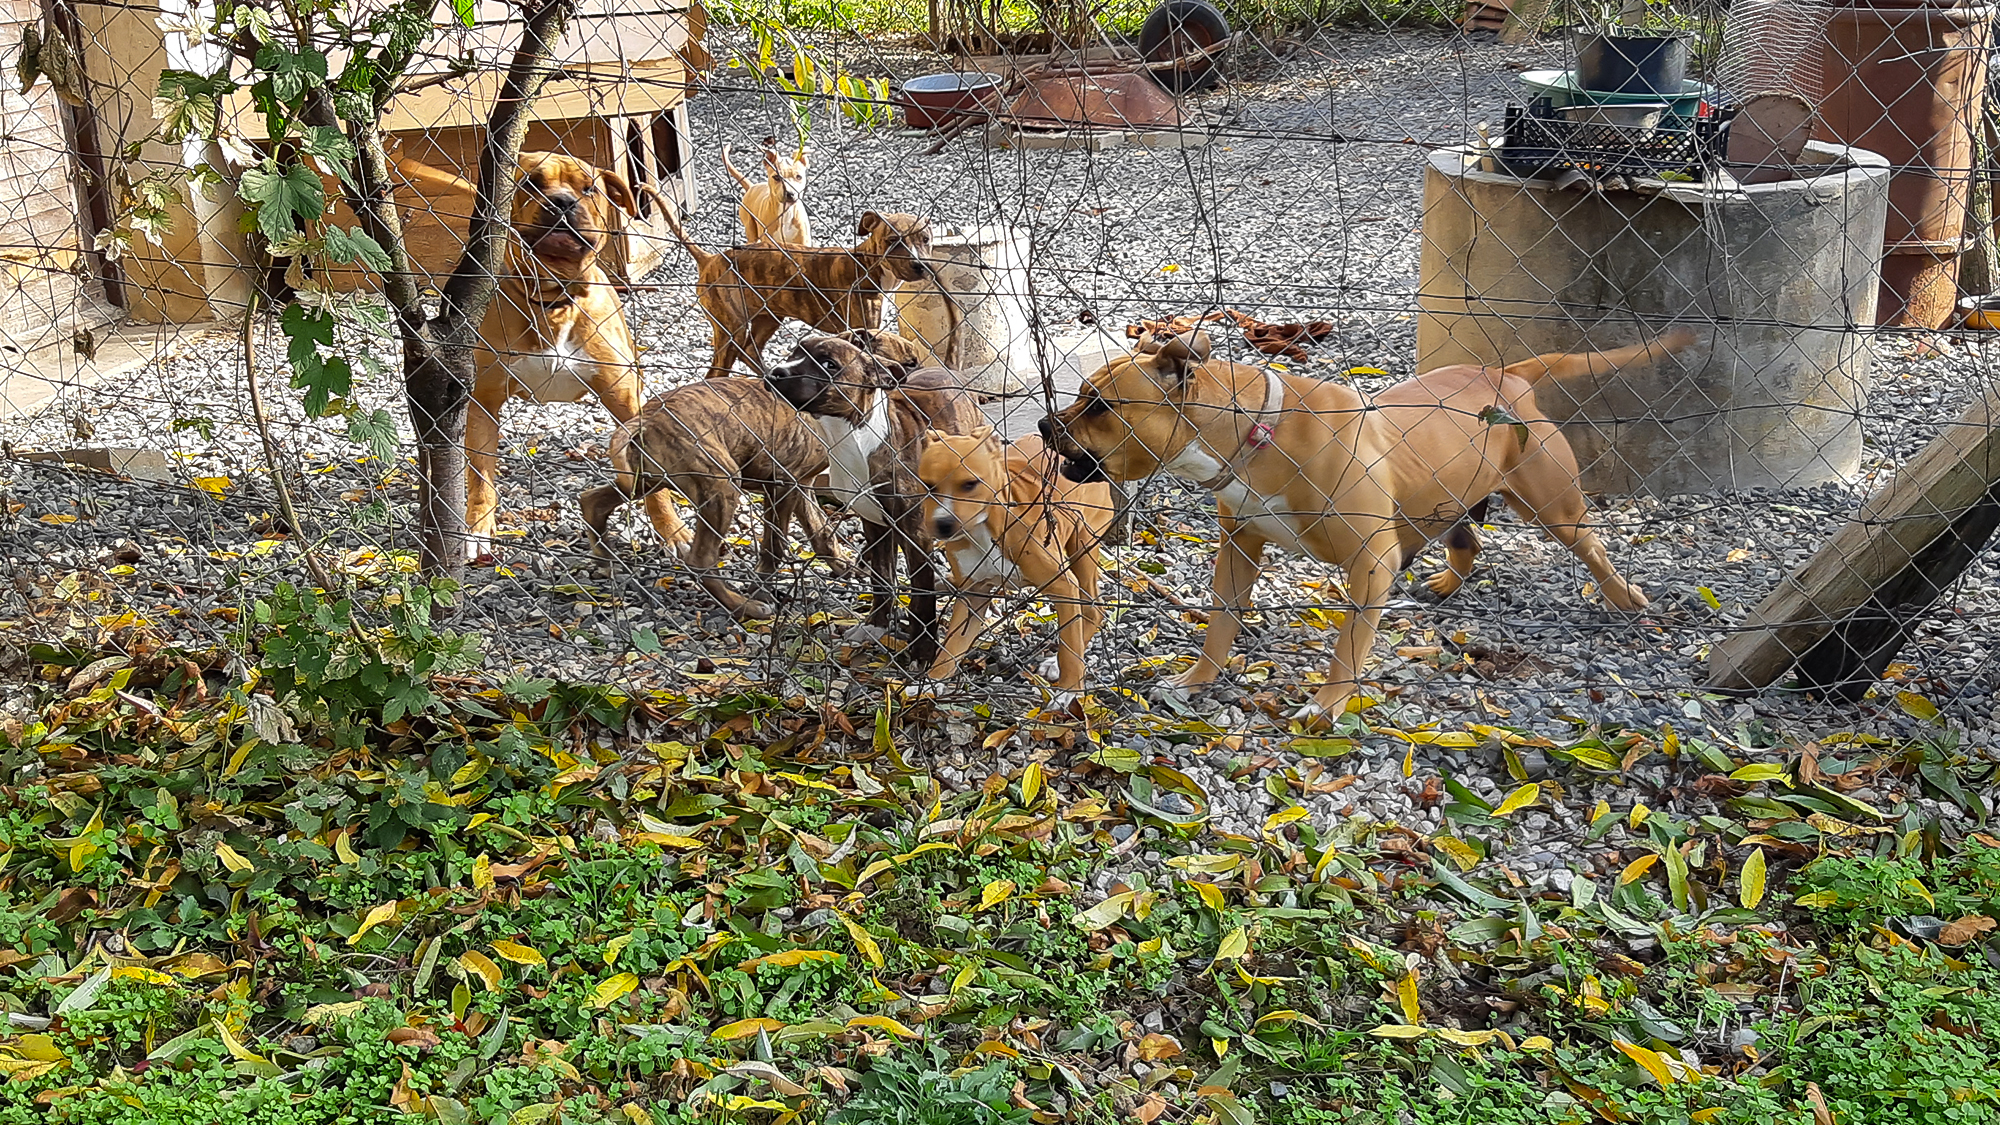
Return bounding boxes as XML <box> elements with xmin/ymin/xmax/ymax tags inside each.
<box><xmin>1416</xmin><ymin>144</ymin><xmax>1890</xmax><ymax>496</ymax></box>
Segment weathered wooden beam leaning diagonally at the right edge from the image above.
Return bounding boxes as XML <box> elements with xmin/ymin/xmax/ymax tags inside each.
<box><xmin>1708</xmin><ymin>376</ymin><xmax>2000</xmax><ymax>699</ymax></box>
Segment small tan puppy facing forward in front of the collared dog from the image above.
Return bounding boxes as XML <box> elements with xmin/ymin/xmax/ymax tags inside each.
<box><xmin>916</xmin><ymin>426</ymin><xmax>1112</xmax><ymax>691</ymax></box>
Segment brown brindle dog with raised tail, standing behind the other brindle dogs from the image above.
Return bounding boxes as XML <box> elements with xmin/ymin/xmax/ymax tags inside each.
<box><xmin>664</xmin><ymin>208</ymin><xmax>960</xmax><ymax>378</ymax></box>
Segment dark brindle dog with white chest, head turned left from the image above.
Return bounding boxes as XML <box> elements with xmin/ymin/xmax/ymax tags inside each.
<box><xmin>764</xmin><ymin>328</ymin><xmax>984</xmax><ymax>665</ymax></box>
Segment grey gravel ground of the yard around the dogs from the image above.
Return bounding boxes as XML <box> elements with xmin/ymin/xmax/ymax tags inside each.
<box><xmin>0</xmin><ymin>30</ymin><xmax>2000</xmax><ymax>856</ymax></box>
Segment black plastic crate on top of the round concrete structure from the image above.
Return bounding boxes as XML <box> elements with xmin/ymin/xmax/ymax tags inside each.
<box><xmin>1496</xmin><ymin>102</ymin><xmax>1728</xmax><ymax>178</ymax></box>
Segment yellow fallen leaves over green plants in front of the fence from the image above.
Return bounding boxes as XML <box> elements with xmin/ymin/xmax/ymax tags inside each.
<box><xmin>0</xmin><ymin>659</ymin><xmax>2000</xmax><ymax>1125</ymax></box>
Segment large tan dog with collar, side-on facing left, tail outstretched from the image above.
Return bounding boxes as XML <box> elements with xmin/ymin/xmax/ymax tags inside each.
<box><xmin>1042</xmin><ymin>328</ymin><xmax>1694</xmax><ymax>719</ymax></box>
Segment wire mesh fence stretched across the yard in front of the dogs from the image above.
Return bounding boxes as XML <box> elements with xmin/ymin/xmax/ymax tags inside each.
<box><xmin>0</xmin><ymin>2</ymin><xmax>2000</xmax><ymax>768</ymax></box>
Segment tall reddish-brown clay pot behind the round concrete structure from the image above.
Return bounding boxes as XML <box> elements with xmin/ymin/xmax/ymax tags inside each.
<box><xmin>1818</xmin><ymin>0</ymin><xmax>1994</xmax><ymax>328</ymax></box>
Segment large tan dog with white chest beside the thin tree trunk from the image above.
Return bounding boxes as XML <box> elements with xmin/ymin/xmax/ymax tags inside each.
<box><xmin>466</xmin><ymin>152</ymin><xmax>690</xmax><ymax>554</ymax></box>
